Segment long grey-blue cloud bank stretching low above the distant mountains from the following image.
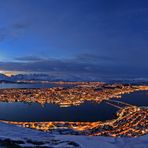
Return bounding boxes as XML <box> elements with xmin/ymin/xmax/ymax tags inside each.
<box><xmin>0</xmin><ymin>54</ymin><xmax>148</xmax><ymax>77</ymax></box>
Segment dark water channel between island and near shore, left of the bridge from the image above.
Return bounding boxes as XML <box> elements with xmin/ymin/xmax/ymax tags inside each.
<box><xmin>0</xmin><ymin>102</ymin><xmax>116</xmax><ymax>121</ymax></box>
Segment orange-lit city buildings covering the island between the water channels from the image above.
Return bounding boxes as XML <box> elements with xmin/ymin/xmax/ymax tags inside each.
<box><xmin>0</xmin><ymin>82</ymin><xmax>148</xmax><ymax>107</ymax></box>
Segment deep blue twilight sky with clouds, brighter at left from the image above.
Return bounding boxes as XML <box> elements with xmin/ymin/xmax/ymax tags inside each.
<box><xmin>0</xmin><ymin>0</ymin><xmax>148</xmax><ymax>77</ymax></box>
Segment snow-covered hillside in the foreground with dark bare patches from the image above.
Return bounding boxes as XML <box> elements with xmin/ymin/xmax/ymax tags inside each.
<box><xmin>0</xmin><ymin>123</ymin><xmax>148</xmax><ymax>148</ymax></box>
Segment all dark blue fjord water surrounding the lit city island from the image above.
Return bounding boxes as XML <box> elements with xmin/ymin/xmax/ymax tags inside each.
<box><xmin>0</xmin><ymin>84</ymin><xmax>148</xmax><ymax>122</ymax></box>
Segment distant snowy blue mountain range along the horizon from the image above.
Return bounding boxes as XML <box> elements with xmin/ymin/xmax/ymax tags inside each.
<box><xmin>0</xmin><ymin>73</ymin><xmax>148</xmax><ymax>84</ymax></box>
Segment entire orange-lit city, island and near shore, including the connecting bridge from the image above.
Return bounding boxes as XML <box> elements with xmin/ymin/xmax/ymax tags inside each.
<box><xmin>0</xmin><ymin>82</ymin><xmax>148</xmax><ymax>137</ymax></box>
